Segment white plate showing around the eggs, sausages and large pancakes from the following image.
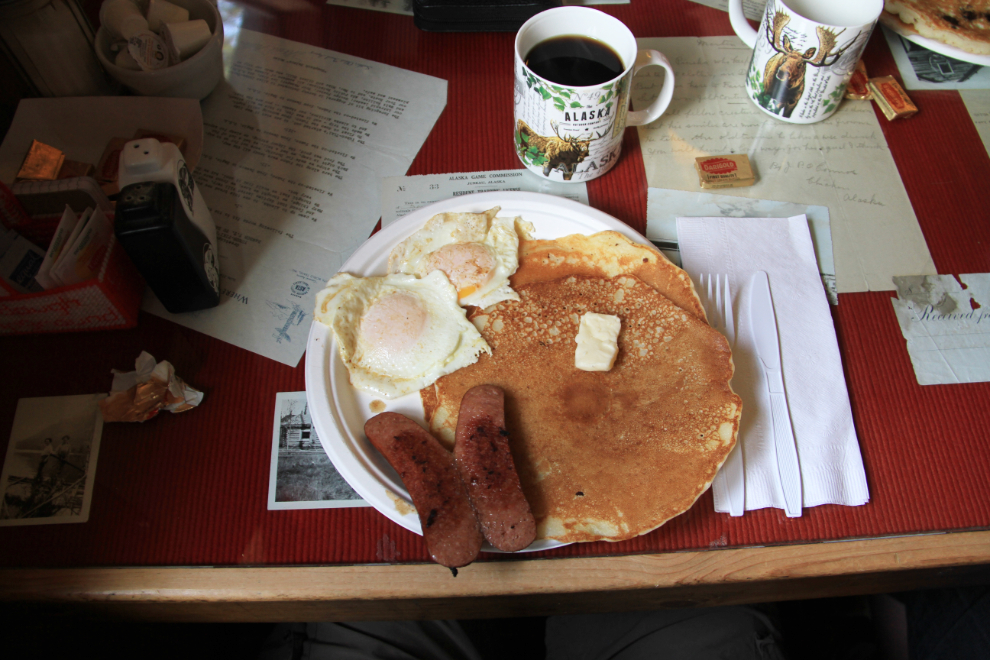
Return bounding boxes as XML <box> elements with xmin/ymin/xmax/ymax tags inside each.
<box><xmin>306</xmin><ymin>192</ymin><xmax>649</xmax><ymax>552</ymax></box>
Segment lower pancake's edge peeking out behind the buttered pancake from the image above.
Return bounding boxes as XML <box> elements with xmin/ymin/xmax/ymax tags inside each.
<box><xmin>509</xmin><ymin>231</ymin><xmax>706</xmax><ymax>320</ymax></box>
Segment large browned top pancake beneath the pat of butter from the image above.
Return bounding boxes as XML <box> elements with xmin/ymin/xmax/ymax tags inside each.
<box><xmin>424</xmin><ymin>276</ymin><xmax>742</xmax><ymax>542</ymax></box>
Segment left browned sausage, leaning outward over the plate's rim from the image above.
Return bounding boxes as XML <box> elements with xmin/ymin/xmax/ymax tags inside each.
<box><xmin>364</xmin><ymin>412</ymin><xmax>483</xmax><ymax>575</ymax></box>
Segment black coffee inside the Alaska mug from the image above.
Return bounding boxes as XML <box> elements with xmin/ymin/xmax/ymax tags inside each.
<box><xmin>525</xmin><ymin>35</ymin><xmax>625</xmax><ymax>87</ymax></box>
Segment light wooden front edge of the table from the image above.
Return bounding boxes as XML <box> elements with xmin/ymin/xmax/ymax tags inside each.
<box><xmin>0</xmin><ymin>531</ymin><xmax>990</xmax><ymax>621</ymax></box>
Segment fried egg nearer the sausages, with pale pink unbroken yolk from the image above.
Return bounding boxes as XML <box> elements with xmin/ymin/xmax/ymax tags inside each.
<box><xmin>315</xmin><ymin>270</ymin><xmax>491</xmax><ymax>399</ymax></box>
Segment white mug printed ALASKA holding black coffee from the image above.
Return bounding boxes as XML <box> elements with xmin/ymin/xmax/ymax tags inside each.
<box><xmin>514</xmin><ymin>7</ymin><xmax>674</xmax><ymax>183</ymax></box>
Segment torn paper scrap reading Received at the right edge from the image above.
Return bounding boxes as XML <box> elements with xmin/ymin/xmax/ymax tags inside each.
<box><xmin>890</xmin><ymin>273</ymin><xmax>990</xmax><ymax>385</ymax></box>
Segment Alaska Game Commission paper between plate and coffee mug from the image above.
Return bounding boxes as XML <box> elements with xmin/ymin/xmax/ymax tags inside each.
<box><xmin>382</xmin><ymin>169</ymin><xmax>588</xmax><ymax>228</ymax></box>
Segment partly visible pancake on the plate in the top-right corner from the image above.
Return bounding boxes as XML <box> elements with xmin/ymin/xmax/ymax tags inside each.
<box><xmin>880</xmin><ymin>0</ymin><xmax>990</xmax><ymax>55</ymax></box>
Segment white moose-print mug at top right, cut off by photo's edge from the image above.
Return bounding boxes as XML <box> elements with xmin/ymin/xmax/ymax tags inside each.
<box><xmin>729</xmin><ymin>0</ymin><xmax>883</xmax><ymax>124</ymax></box>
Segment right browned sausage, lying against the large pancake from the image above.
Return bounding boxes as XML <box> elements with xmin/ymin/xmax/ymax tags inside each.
<box><xmin>454</xmin><ymin>385</ymin><xmax>536</xmax><ymax>552</ymax></box>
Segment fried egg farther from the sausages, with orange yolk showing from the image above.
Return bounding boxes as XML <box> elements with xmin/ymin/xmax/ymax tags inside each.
<box><xmin>388</xmin><ymin>206</ymin><xmax>533</xmax><ymax>308</ymax></box>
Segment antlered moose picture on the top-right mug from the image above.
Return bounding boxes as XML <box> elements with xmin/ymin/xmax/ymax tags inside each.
<box><xmin>756</xmin><ymin>11</ymin><xmax>859</xmax><ymax>117</ymax></box>
